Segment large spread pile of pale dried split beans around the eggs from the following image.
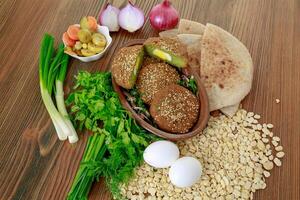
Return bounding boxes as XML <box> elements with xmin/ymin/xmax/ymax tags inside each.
<box><xmin>121</xmin><ymin>109</ymin><xmax>283</xmax><ymax>200</ymax></box>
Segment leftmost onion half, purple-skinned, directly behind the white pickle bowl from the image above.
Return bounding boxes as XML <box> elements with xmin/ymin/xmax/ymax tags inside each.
<box><xmin>99</xmin><ymin>3</ymin><xmax>120</xmax><ymax>32</ymax></box>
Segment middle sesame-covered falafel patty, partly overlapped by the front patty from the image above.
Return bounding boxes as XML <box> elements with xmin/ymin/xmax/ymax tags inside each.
<box><xmin>136</xmin><ymin>63</ymin><xmax>180</xmax><ymax>104</ymax></box>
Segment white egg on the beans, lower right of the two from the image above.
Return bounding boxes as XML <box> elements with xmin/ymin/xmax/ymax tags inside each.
<box><xmin>169</xmin><ymin>157</ymin><xmax>202</xmax><ymax>188</ymax></box>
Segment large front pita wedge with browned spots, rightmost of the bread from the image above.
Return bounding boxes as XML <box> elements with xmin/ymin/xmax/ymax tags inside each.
<box><xmin>200</xmin><ymin>24</ymin><xmax>253</xmax><ymax>111</ymax></box>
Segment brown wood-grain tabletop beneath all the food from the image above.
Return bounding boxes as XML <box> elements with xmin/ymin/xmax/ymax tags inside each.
<box><xmin>0</xmin><ymin>0</ymin><xmax>300</xmax><ymax>200</ymax></box>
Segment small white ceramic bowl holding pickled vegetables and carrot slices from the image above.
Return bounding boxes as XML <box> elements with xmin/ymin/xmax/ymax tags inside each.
<box><xmin>65</xmin><ymin>24</ymin><xmax>112</xmax><ymax>62</ymax></box>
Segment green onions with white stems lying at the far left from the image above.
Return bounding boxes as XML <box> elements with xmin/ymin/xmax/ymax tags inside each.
<box><xmin>39</xmin><ymin>34</ymin><xmax>77</xmax><ymax>141</ymax></box>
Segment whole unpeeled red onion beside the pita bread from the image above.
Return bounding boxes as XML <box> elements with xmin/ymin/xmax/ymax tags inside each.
<box><xmin>149</xmin><ymin>0</ymin><xmax>179</xmax><ymax>31</ymax></box>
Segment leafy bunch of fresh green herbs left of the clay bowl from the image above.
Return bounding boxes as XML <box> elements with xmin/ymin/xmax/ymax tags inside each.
<box><xmin>66</xmin><ymin>72</ymin><xmax>156</xmax><ymax>200</ymax></box>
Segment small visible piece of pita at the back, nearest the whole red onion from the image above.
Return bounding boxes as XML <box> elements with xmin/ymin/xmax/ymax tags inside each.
<box><xmin>178</xmin><ymin>19</ymin><xmax>205</xmax><ymax>35</ymax></box>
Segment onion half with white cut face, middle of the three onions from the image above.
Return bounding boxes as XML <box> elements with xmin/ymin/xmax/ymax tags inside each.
<box><xmin>119</xmin><ymin>1</ymin><xmax>145</xmax><ymax>32</ymax></box>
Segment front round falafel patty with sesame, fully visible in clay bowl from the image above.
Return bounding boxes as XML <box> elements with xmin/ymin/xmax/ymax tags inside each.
<box><xmin>150</xmin><ymin>84</ymin><xmax>199</xmax><ymax>133</ymax></box>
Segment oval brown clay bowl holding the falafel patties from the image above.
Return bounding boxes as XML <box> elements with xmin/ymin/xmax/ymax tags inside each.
<box><xmin>112</xmin><ymin>39</ymin><xmax>209</xmax><ymax>141</ymax></box>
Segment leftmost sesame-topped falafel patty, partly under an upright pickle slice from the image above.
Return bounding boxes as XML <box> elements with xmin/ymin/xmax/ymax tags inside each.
<box><xmin>111</xmin><ymin>45</ymin><xmax>144</xmax><ymax>89</ymax></box>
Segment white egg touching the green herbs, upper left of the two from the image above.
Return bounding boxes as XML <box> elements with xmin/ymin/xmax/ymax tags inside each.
<box><xmin>143</xmin><ymin>140</ymin><xmax>179</xmax><ymax>168</ymax></box>
